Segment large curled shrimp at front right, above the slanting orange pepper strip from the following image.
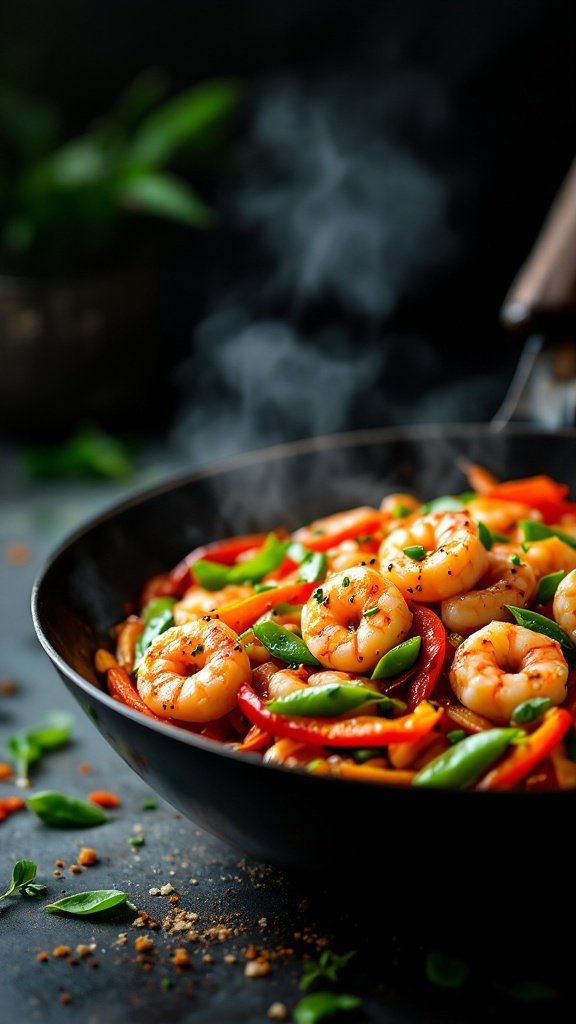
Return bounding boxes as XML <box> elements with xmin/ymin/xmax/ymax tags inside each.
<box><xmin>450</xmin><ymin>623</ymin><xmax>568</xmax><ymax>722</ymax></box>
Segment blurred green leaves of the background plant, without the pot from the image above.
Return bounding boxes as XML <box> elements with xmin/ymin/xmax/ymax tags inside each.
<box><xmin>0</xmin><ymin>70</ymin><xmax>241</xmax><ymax>271</ymax></box>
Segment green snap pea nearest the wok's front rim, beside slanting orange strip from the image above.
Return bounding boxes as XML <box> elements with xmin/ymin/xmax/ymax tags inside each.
<box><xmin>412</xmin><ymin>728</ymin><xmax>523</xmax><ymax>790</ymax></box>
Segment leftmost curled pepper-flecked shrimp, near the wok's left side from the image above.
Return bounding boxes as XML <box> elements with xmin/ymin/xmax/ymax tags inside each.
<box><xmin>136</xmin><ymin>618</ymin><xmax>251</xmax><ymax>722</ymax></box>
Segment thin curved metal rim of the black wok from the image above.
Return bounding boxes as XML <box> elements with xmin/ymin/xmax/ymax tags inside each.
<box><xmin>31</xmin><ymin>423</ymin><xmax>576</xmax><ymax>801</ymax></box>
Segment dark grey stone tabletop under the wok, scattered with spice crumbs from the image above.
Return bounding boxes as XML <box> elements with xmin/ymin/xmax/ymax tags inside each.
<box><xmin>0</xmin><ymin>449</ymin><xmax>566</xmax><ymax>1024</ymax></box>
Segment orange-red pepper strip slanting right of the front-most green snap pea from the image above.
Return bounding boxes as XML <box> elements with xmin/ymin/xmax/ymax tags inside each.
<box><xmin>476</xmin><ymin>708</ymin><xmax>572</xmax><ymax>790</ymax></box>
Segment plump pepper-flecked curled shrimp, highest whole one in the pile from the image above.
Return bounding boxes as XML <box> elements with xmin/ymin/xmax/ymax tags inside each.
<box><xmin>379</xmin><ymin>512</ymin><xmax>489</xmax><ymax>601</ymax></box>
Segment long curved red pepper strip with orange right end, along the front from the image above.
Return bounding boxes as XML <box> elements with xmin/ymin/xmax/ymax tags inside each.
<box><xmin>238</xmin><ymin>683</ymin><xmax>444</xmax><ymax>746</ymax></box>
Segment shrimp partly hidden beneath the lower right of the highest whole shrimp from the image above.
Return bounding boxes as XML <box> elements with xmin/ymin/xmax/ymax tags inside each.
<box><xmin>440</xmin><ymin>545</ymin><xmax>536</xmax><ymax>636</ymax></box>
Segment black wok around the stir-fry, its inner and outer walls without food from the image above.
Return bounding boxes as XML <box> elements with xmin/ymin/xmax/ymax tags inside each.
<box><xmin>32</xmin><ymin>424</ymin><xmax>576</xmax><ymax>871</ymax></box>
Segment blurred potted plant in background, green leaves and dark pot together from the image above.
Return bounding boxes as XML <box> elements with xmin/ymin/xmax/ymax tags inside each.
<box><xmin>0</xmin><ymin>72</ymin><xmax>239</xmax><ymax>438</ymax></box>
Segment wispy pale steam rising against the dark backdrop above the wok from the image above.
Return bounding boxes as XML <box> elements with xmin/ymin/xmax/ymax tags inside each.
<box><xmin>168</xmin><ymin>71</ymin><xmax>481</xmax><ymax>464</ymax></box>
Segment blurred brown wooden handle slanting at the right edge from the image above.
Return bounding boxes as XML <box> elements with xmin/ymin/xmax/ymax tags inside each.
<box><xmin>500</xmin><ymin>158</ymin><xmax>576</xmax><ymax>337</ymax></box>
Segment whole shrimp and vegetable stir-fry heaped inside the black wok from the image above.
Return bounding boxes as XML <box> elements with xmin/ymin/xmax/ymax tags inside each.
<box><xmin>95</xmin><ymin>465</ymin><xmax>576</xmax><ymax>792</ymax></box>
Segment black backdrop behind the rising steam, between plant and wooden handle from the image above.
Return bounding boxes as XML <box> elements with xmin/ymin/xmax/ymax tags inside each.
<box><xmin>0</xmin><ymin>0</ymin><xmax>576</xmax><ymax>459</ymax></box>
